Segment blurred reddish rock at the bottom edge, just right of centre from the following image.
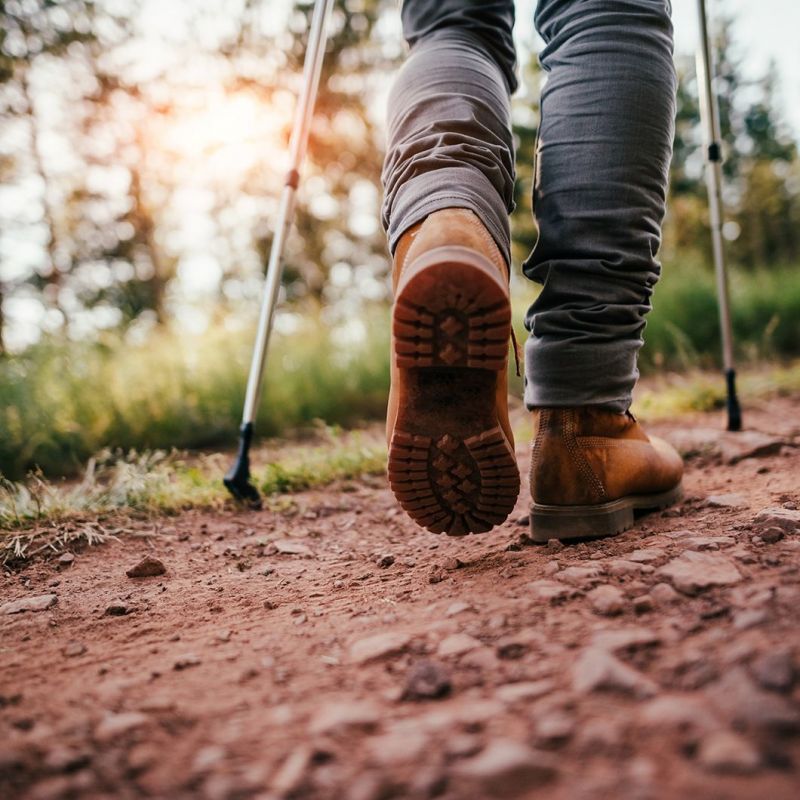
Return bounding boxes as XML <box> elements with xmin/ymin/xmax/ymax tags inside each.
<box><xmin>453</xmin><ymin>739</ymin><xmax>557</xmax><ymax>797</ymax></box>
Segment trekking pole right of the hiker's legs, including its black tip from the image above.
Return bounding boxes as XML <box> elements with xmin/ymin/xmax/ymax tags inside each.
<box><xmin>697</xmin><ymin>0</ymin><xmax>742</xmax><ymax>431</ymax></box>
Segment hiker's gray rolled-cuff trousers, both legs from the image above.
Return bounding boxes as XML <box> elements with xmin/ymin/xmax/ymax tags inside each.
<box><xmin>383</xmin><ymin>0</ymin><xmax>676</xmax><ymax>411</ymax></box>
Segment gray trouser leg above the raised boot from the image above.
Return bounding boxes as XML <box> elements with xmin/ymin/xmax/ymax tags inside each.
<box><xmin>382</xmin><ymin>0</ymin><xmax>517</xmax><ymax>262</ymax></box>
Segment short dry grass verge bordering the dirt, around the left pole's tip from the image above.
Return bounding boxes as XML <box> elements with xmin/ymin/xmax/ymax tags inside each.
<box><xmin>0</xmin><ymin>429</ymin><xmax>386</xmax><ymax>564</ymax></box>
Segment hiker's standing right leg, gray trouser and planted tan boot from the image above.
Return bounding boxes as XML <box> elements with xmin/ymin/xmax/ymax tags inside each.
<box><xmin>524</xmin><ymin>0</ymin><xmax>683</xmax><ymax>541</ymax></box>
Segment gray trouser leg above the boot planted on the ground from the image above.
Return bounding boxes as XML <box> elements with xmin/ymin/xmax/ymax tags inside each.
<box><xmin>524</xmin><ymin>0</ymin><xmax>676</xmax><ymax>411</ymax></box>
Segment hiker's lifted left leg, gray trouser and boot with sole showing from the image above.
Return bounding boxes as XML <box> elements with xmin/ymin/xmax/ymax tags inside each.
<box><xmin>383</xmin><ymin>0</ymin><xmax>519</xmax><ymax>534</ymax></box>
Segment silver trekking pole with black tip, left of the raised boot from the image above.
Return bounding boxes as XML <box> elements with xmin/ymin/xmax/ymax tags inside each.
<box><xmin>223</xmin><ymin>0</ymin><xmax>333</xmax><ymax>506</ymax></box>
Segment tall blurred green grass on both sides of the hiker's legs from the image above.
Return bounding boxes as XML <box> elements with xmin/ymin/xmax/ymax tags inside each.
<box><xmin>0</xmin><ymin>263</ymin><xmax>800</xmax><ymax>480</ymax></box>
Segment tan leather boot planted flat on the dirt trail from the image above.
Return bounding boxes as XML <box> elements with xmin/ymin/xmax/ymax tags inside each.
<box><xmin>530</xmin><ymin>407</ymin><xmax>683</xmax><ymax>542</ymax></box>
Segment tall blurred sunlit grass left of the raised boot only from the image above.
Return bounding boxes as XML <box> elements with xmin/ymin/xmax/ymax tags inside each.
<box><xmin>0</xmin><ymin>309</ymin><xmax>389</xmax><ymax>480</ymax></box>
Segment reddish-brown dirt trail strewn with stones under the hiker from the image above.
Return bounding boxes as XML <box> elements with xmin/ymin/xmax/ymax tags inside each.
<box><xmin>0</xmin><ymin>398</ymin><xmax>800</xmax><ymax>800</ymax></box>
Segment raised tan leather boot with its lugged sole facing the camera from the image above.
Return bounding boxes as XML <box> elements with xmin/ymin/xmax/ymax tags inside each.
<box><xmin>386</xmin><ymin>209</ymin><xmax>519</xmax><ymax>535</ymax></box>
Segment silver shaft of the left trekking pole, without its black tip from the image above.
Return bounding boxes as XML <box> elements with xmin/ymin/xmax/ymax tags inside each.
<box><xmin>242</xmin><ymin>0</ymin><xmax>333</xmax><ymax>425</ymax></box>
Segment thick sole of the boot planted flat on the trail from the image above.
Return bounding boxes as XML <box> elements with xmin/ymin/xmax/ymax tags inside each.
<box><xmin>530</xmin><ymin>483</ymin><xmax>683</xmax><ymax>542</ymax></box>
